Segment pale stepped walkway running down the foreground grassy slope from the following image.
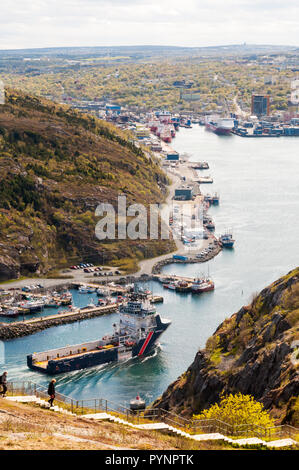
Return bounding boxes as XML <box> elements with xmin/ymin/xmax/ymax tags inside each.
<box><xmin>6</xmin><ymin>395</ymin><xmax>297</xmax><ymax>448</ymax></box>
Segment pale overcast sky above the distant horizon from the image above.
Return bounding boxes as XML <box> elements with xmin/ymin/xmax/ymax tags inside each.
<box><xmin>0</xmin><ymin>0</ymin><xmax>299</xmax><ymax>49</ymax></box>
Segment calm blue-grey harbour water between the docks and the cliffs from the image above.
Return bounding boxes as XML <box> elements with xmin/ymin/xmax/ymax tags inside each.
<box><xmin>2</xmin><ymin>125</ymin><xmax>299</xmax><ymax>403</ymax></box>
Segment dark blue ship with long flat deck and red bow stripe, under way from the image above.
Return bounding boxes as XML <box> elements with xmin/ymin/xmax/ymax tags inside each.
<box><xmin>27</xmin><ymin>292</ymin><xmax>171</xmax><ymax>375</ymax></box>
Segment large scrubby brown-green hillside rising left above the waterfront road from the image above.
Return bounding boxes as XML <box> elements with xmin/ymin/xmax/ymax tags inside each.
<box><xmin>0</xmin><ymin>90</ymin><xmax>176</xmax><ymax>279</ymax></box>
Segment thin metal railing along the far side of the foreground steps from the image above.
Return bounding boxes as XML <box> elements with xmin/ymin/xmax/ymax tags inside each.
<box><xmin>7</xmin><ymin>381</ymin><xmax>299</xmax><ymax>441</ymax></box>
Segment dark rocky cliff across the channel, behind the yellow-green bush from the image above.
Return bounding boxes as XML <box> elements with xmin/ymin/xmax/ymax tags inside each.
<box><xmin>154</xmin><ymin>268</ymin><xmax>299</xmax><ymax>426</ymax></box>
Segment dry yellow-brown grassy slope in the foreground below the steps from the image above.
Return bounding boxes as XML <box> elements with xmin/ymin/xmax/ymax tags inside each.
<box><xmin>0</xmin><ymin>399</ymin><xmax>231</xmax><ymax>450</ymax></box>
